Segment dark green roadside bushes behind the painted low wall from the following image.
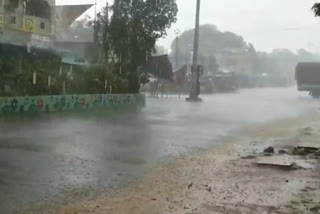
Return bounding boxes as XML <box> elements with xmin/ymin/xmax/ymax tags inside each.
<box><xmin>0</xmin><ymin>45</ymin><xmax>119</xmax><ymax>97</ymax></box>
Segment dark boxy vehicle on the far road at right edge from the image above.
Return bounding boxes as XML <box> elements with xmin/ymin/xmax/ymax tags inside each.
<box><xmin>296</xmin><ymin>62</ymin><xmax>320</xmax><ymax>98</ymax></box>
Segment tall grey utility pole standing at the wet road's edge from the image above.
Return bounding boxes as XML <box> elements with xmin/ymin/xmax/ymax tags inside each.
<box><xmin>187</xmin><ymin>0</ymin><xmax>201</xmax><ymax>102</ymax></box>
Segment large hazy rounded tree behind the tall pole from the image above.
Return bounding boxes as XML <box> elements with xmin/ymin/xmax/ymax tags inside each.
<box><xmin>170</xmin><ymin>25</ymin><xmax>249</xmax><ymax>73</ymax></box>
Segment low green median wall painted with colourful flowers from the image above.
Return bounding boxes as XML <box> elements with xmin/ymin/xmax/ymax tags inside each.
<box><xmin>0</xmin><ymin>94</ymin><xmax>145</xmax><ymax>115</ymax></box>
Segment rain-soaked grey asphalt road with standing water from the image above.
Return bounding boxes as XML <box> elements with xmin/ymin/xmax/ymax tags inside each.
<box><xmin>0</xmin><ymin>88</ymin><xmax>319</xmax><ymax>213</ymax></box>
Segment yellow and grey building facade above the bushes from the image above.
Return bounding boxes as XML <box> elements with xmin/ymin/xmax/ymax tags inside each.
<box><xmin>0</xmin><ymin>0</ymin><xmax>55</xmax><ymax>48</ymax></box>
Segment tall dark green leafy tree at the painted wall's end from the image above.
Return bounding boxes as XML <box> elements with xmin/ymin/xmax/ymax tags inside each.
<box><xmin>99</xmin><ymin>0</ymin><xmax>178</xmax><ymax>93</ymax></box>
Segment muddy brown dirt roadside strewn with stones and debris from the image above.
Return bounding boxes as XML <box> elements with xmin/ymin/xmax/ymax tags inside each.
<box><xmin>48</xmin><ymin>112</ymin><xmax>320</xmax><ymax>214</ymax></box>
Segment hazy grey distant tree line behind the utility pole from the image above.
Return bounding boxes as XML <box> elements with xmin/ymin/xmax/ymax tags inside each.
<box><xmin>170</xmin><ymin>25</ymin><xmax>320</xmax><ymax>86</ymax></box>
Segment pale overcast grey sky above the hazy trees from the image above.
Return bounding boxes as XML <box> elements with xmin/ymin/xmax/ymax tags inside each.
<box><xmin>57</xmin><ymin>0</ymin><xmax>320</xmax><ymax>53</ymax></box>
